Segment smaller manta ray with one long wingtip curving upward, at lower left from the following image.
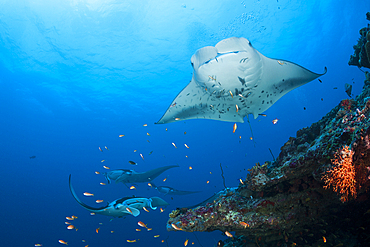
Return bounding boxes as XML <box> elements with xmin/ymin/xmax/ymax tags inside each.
<box><xmin>69</xmin><ymin>175</ymin><xmax>169</xmax><ymax>218</ymax></box>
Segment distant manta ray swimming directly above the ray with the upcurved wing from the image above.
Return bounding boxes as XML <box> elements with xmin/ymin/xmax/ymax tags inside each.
<box><xmin>103</xmin><ymin>165</ymin><xmax>179</xmax><ymax>184</ymax></box>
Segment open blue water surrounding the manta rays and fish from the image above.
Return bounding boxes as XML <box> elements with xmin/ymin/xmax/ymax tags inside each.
<box><xmin>0</xmin><ymin>0</ymin><xmax>370</xmax><ymax>247</ymax></box>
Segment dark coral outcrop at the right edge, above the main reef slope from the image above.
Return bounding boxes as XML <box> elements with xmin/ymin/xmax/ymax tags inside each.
<box><xmin>348</xmin><ymin>12</ymin><xmax>370</xmax><ymax>68</ymax></box>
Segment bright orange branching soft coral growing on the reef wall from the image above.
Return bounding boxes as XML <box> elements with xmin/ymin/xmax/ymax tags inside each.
<box><xmin>323</xmin><ymin>146</ymin><xmax>357</xmax><ymax>202</ymax></box>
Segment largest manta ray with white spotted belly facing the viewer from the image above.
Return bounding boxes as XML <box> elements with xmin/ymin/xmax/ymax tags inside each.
<box><xmin>157</xmin><ymin>37</ymin><xmax>327</xmax><ymax>124</ymax></box>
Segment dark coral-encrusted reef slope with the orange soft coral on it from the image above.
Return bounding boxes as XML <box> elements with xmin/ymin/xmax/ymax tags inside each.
<box><xmin>167</xmin><ymin>14</ymin><xmax>370</xmax><ymax>247</ymax></box>
